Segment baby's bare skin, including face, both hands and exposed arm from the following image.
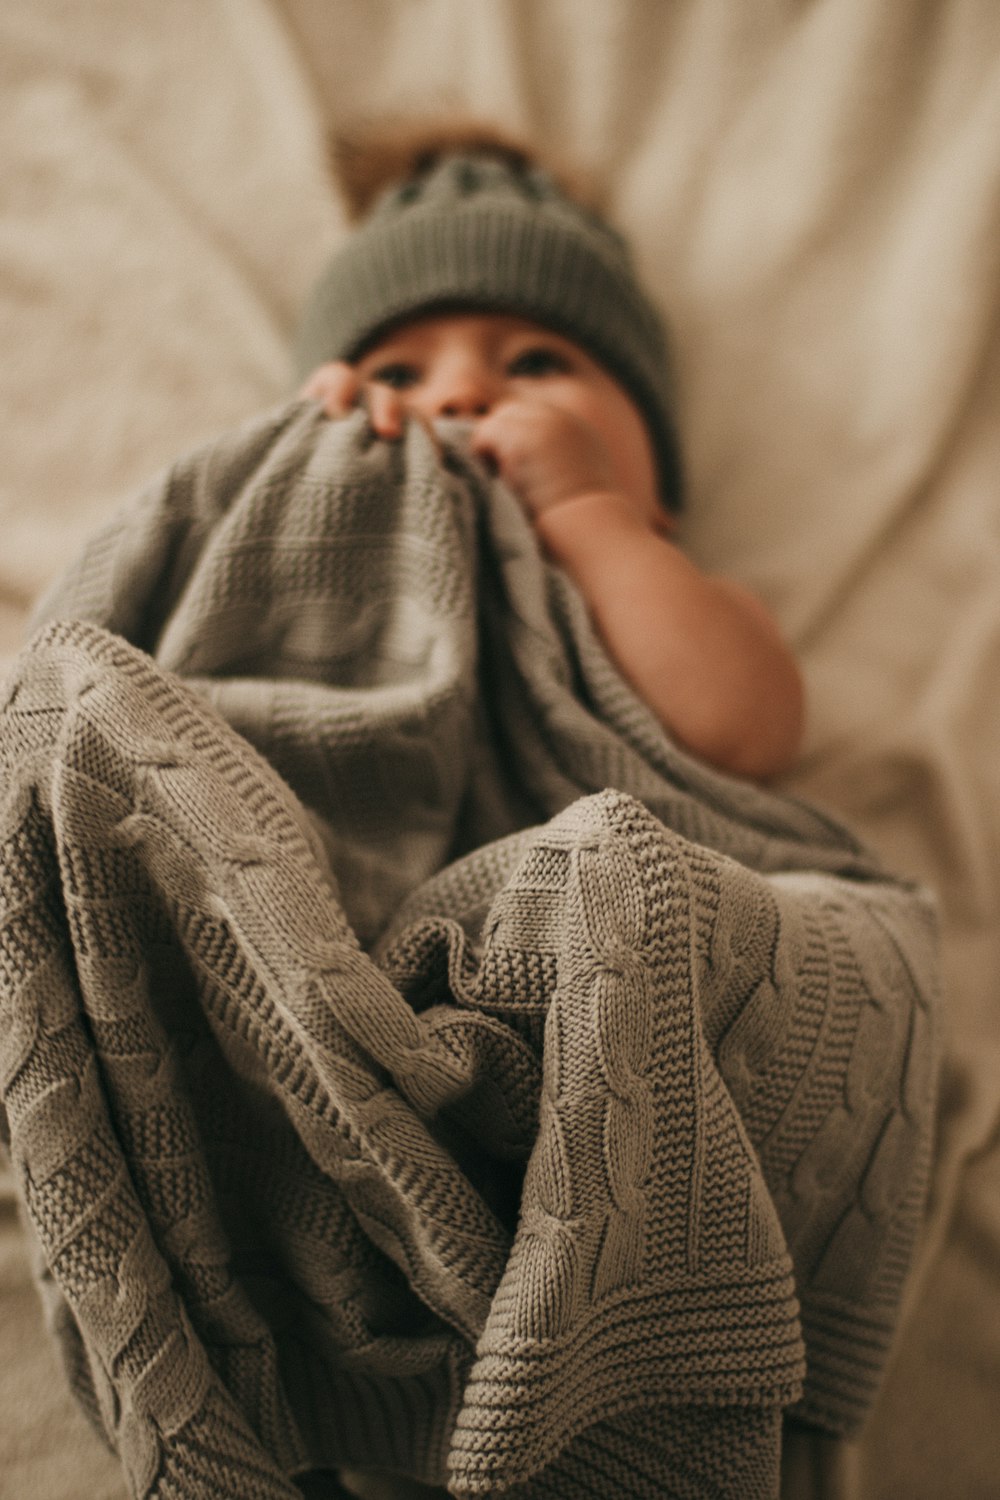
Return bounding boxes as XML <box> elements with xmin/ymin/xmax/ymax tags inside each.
<box><xmin>301</xmin><ymin>312</ymin><xmax>804</xmax><ymax>779</ymax></box>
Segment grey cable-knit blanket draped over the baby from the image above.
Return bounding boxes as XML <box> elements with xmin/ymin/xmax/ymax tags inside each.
<box><xmin>0</xmin><ymin>402</ymin><xmax>936</xmax><ymax>1500</ymax></box>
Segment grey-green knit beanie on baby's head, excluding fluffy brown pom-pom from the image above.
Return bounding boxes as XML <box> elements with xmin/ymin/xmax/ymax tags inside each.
<box><xmin>295</xmin><ymin>139</ymin><xmax>681</xmax><ymax>510</ymax></box>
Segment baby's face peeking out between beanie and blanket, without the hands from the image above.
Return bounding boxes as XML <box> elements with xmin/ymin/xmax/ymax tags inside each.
<box><xmin>355</xmin><ymin>314</ymin><xmax>663</xmax><ymax>519</ymax></box>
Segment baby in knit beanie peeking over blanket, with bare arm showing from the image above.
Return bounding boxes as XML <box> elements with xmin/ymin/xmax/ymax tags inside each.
<box><xmin>293</xmin><ymin>131</ymin><xmax>804</xmax><ymax>779</ymax></box>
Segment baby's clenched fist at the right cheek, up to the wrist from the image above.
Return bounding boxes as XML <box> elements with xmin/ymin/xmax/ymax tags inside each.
<box><xmin>472</xmin><ymin>398</ymin><xmax>616</xmax><ymax>516</ymax></box>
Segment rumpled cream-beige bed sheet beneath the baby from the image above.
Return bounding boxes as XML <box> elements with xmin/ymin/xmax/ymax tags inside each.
<box><xmin>0</xmin><ymin>0</ymin><xmax>1000</xmax><ymax>1500</ymax></box>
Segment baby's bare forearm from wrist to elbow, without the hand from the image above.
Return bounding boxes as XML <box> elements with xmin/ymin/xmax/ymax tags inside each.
<box><xmin>534</xmin><ymin>492</ymin><xmax>802</xmax><ymax>777</ymax></box>
